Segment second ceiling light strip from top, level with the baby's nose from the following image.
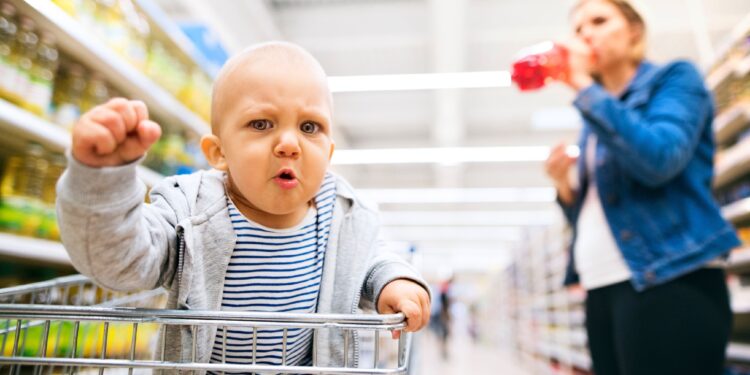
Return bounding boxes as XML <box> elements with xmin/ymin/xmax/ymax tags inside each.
<box><xmin>331</xmin><ymin>146</ymin><xmax>579</xmax><ymax>165</ymax></box>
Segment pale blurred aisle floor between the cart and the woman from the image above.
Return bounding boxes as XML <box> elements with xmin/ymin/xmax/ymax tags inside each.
<box><xmin>414</xmin><ymin>332</ymin><xmax>531</xmax><ymax>375</ymax></box>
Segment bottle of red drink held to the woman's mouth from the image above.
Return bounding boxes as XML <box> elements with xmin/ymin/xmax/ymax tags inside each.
<box><xmin>511</xmin><ymin>42</ymin><xmax>568</xmax><ymax>91</ymax></box>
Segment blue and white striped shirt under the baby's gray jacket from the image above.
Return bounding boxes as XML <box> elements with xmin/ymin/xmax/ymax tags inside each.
<box><xmin>211</xmin><ymin>174</ymin><xmax>336</xmax><ymax>372</ymax></box>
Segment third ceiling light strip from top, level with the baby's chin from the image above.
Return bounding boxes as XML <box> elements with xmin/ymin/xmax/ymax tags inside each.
<box><xmin>357</xmin><ymin>187</ymin><xmax>555</xmax><ymax>203</ymax></box>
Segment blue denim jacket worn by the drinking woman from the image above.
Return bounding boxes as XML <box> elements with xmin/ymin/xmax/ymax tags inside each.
<box><xmin>560</xmin><ymin>61</ymin><xmax>740</xmax><ymax>291</ymax></box>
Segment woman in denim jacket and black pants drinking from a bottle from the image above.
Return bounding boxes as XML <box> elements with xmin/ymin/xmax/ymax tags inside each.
<box><xmin>545</xmin><ymin>0</ymin><xmax>739</xmax><ymax>375</ymax></box>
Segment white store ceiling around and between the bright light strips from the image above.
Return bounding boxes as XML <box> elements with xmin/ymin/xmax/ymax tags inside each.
<box><xmin>160</xmin><ymin>0</ymin><xmax>750</xmax><ymax>276</ymax></box>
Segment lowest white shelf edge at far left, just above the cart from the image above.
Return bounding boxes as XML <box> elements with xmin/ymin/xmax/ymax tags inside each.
<box><xmin>0</xmin><ymin>233</ymin><xmax>71</xmax><ymax>266</ymax></box>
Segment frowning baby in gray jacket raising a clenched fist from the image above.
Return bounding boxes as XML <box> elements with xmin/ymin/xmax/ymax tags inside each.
<box><xmin>57</xmin><ymin>42</ymin><xmax>430</xmax><ymax>372</ymax></box>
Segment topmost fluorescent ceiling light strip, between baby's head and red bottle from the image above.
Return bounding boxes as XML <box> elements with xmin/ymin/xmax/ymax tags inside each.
<box><xmin>328</xmin><ymin>70</ymin><xmax>510</xmax><ymax>93</ymax></box>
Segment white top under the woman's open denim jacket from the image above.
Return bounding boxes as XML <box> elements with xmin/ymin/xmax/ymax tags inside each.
<box><xmin>574</xmin><ymin>134</ymin><xmax>631</xmax><ymax>290</ymax></box>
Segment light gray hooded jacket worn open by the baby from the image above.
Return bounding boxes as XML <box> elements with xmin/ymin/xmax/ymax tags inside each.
<box><xmin>57</xmin><ymin>156</ymin><xmax>429</xmax><ymax>367</ymax></box>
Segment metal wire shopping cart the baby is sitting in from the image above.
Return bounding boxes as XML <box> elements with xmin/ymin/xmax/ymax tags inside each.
<box><xmin>0</xmin><ymin>275</ymin><xmax>411</xmax><ymax>375</ymax></box>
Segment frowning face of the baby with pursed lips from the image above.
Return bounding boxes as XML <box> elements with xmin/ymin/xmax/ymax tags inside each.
<box><xmin>217</xmin><ymin>60</ymin><xmax>333</xmax><ymax>222</ymax></box>
